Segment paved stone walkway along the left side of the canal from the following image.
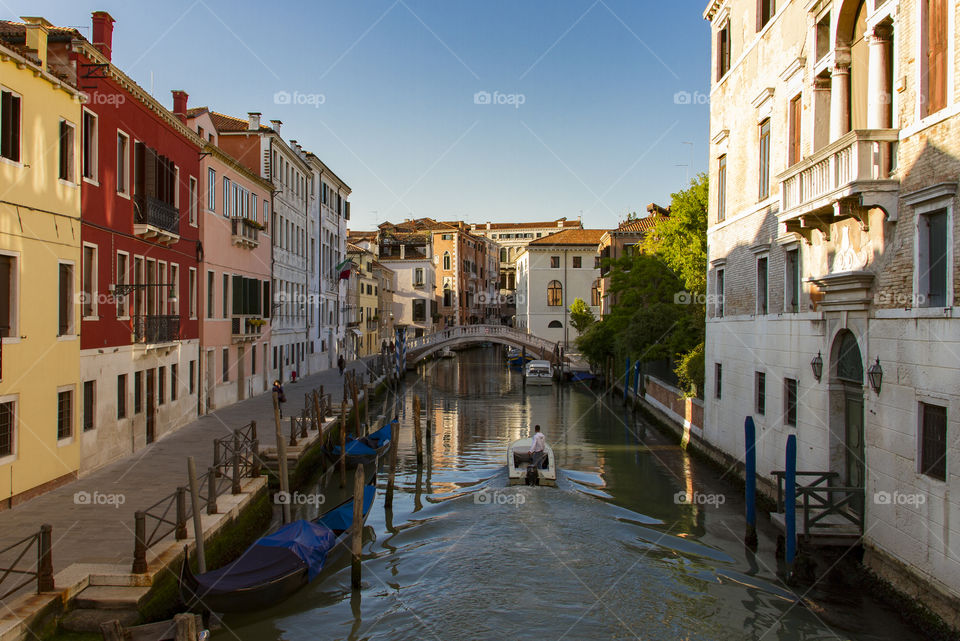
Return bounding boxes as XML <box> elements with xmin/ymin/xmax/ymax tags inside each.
<box><xmin>0</xmin><ymin>357</ymin><xmax>382</xmax><ymax>592</ymax></box>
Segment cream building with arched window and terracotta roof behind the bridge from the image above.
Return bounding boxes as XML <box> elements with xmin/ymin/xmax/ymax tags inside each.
<box><xmin>516</xmin><ymin>229</ymin><xmax>605</xmax><ymax>346</ymax></box>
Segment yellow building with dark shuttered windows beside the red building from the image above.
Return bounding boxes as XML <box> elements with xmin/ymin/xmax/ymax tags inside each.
<box><xmin>0</xmin><ymin>18</ymin><xmax>82</xmax><ymax>509</ymax></box>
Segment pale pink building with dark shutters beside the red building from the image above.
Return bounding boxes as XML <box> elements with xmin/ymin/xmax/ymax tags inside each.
<box><xmin>173</xmin><ymin>100</ymin><xmax>275</xmax><ymax>412</ymax></box>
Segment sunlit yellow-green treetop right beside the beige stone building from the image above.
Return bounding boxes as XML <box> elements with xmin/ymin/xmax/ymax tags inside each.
<box><xmin>643</xmin><ymin>173</ymin><xmax>709</xmax><ymax>294</ymax></box>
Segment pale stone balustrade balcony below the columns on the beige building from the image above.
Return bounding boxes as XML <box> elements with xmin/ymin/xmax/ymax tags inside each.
<box><xmin>777</xmin><ymin>129</ymin><xmax>900</xmax><ymax>240</ymax></box>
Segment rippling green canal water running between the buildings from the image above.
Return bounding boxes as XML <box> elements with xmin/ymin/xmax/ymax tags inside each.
<box><xmin>214</xmin><ymin>347</ymin><xmax>922</xmax><ymax>641</ymax></box>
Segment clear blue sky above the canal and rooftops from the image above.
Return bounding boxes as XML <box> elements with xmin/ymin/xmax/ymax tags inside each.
<box><xmin>9</xmin><ymin>0</ymin><xmax>710</xmax><ymax>229</ymax></box>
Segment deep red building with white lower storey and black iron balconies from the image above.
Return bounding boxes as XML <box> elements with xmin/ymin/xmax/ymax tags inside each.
<box><xmin>44</xmin><ymin>11</ymin><xmax>203</xmax><ymax>473</ymax></box>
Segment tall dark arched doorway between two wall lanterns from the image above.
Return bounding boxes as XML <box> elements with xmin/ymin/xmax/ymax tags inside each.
<box><xmin>830</xmin><ymin>330</ymin><xmax>866</xmax><ymax>509</ymax></box>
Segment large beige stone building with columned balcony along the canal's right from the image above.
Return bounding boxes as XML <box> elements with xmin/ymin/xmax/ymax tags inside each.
<box><xmin>697</xmin><ymin>0</ymin><xmax>960</xmax><ymax>626</ymax></box>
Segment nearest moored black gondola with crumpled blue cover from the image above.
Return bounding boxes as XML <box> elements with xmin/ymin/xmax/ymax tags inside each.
<box><xmin>180</xmin><ymin>484</ymin><xmax>377</xmax><ymax>612</ymax></box>
